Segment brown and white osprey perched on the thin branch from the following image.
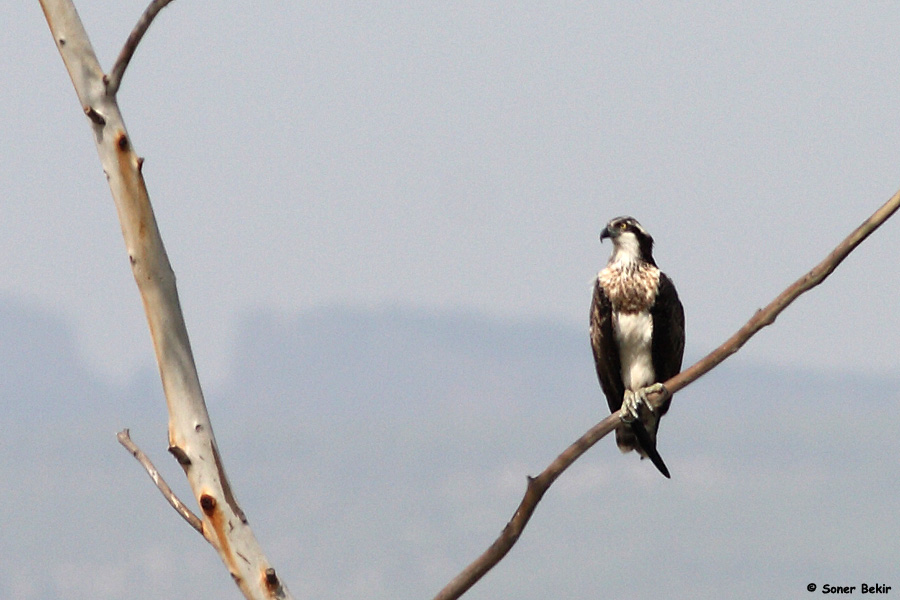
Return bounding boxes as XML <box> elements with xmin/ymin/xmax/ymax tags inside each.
<box><xmin>590</xmin><ymin>217</ymin><xmax>684</xmax><ymax>477</ymax></box>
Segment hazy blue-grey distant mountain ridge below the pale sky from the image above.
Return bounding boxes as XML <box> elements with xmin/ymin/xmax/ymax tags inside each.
<box><xmin>0</xmin><ymin>301</ymin><xmax>900</xmax><ymax>600</ymax></box>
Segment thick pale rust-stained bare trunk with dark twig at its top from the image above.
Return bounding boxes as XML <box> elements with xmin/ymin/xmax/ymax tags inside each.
<box><xmin>41</xmin><ymin>0</ymin><xmax>291</xmax><ymax>600</ymax></box>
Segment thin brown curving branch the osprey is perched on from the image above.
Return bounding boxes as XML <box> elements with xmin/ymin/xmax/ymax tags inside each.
<box><xmin>434</xmin><ymin>191</ymin><xmax>900</xmax><ymax>600</ymax></box>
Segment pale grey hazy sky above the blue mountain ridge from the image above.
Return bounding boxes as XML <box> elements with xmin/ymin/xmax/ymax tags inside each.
<box><xmin>0</xmin><ymin>0</ymin><xmax>900</xmax><ymax>380</ymax></box>
